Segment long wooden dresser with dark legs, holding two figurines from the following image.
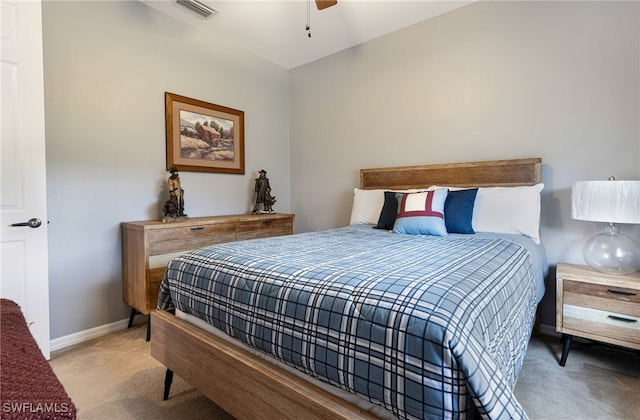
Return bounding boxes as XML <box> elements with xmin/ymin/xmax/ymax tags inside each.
<box><xmin>121</xmin><ymin>213</ymin><xmax>295</xmax><ymax>340</ymax></box>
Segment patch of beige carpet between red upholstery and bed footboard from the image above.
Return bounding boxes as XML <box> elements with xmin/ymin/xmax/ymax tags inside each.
<box><xmin>50</xmin><ymin>324</ymin><xmax>231</xmax><ymax>420</ymax></box>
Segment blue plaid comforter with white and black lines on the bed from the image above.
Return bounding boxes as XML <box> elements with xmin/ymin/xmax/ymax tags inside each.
<box><xmin>158</xmin><ymin>226</ymin><xmax>544</xmax><ymax>418</ymax></box>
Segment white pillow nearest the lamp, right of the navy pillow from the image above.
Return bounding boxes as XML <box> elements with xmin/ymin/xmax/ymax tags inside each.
<box><xmin>471</xmin><ymin>184</ymin><xmax>544</xmax><ymax>244</ymax></box>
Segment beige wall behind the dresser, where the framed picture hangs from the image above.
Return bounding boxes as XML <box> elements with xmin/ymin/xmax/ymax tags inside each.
<box><xmin>43</xmin><ymin>1</ymin><xmax>290</xmax><ymax>338</ymax></box>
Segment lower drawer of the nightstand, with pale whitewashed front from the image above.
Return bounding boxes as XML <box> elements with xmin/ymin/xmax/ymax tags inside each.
<box><xmin>563</xmin><ymin>304</ymin><xmax>640</xmax><ymax>344</ymax></box>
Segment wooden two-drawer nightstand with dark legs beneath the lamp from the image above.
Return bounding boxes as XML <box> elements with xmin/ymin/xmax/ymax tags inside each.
<box><xmin>556</xmin><ymin>264</ymin><xmax>640</xmax><ymax>366</ymax></box>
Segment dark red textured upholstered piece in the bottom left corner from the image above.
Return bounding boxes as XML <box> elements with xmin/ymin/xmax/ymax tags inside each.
<box><xmin>0</xmin><ymin>299</ymin><xmax>76</xmax><ymax>419</ymax></box>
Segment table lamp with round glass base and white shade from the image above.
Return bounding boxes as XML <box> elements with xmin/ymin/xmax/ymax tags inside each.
<box><xmin>571</xmin><ymin>177</ymin><xmax>640</xmax><ymax>274</ymax></box>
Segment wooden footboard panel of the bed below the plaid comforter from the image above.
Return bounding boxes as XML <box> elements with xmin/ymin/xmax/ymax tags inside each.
<box><xmin>151</xmin><ymin>311</ymin><xmax>374</xmax><ymax>419</ymax></box>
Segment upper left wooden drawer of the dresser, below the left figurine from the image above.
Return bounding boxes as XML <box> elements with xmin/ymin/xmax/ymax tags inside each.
<box><xmin>148</xmin><ymin>223</ymin><xmax>236</xmax><ymax>255</ymax></box>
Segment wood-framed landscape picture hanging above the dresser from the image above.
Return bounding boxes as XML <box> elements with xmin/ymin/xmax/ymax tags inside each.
<box><xmin>164</xmin><ymin>92</ymin><xmax>244</xmax><ymax>174</ymax></box>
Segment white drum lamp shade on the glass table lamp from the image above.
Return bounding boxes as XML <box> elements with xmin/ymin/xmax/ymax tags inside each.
<box><xmin>571</xmin><ymin>181</ymin><xmax>640</xmax><ymax>224</ymax></box>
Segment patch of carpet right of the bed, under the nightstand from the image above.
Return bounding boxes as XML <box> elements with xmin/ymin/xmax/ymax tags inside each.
<box><xmin>516</xmin><ymin>335</ymin><xmax>640</xmax><ymax>420</ymax></box>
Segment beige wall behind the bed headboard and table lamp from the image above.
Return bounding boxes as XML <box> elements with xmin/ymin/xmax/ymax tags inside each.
<box><xmin>290</xmin><ymin>1</ymin><xmax>640</xmax><ymax>324</ymax></box>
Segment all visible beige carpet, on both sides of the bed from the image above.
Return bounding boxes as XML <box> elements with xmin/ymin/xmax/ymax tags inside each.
<box><xmin>51</xmin><ymin>325</ymin><xmax>640</xmax><ymax>420</ymax></box>
